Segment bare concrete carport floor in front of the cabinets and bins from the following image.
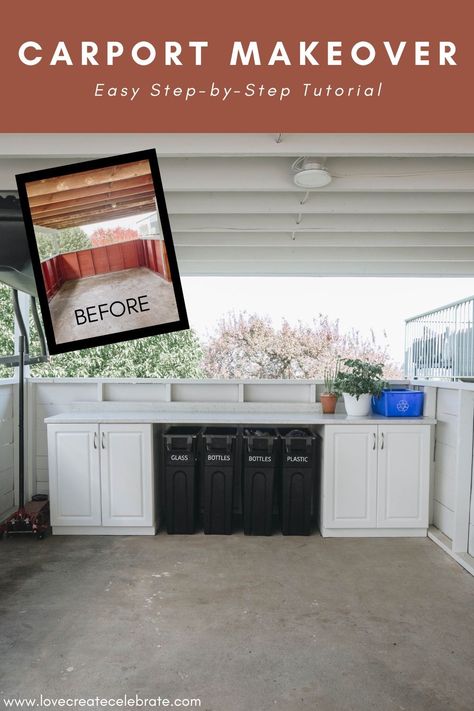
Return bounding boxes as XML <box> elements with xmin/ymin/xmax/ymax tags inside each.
<box><xmin>0</xmin><ymin>534</ymin><xmax>474</xmax><ymax>711</ymax></box>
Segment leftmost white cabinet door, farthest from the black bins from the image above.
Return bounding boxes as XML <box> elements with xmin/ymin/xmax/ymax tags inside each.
<box><xmin>48</xmin><ymin>425</ymin><xmax>101</xmax><ymax>526</ymax></box>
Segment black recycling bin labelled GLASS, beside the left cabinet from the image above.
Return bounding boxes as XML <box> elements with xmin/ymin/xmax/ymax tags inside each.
<box><xmin>163</xmin><ymin>427</ymin><xmax>201</xmax><ymax>533</ymax></box>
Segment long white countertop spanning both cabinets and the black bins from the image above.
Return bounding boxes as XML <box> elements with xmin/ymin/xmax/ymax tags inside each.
<box><xmin>45</xmin><ymin>408</ymin><xmax>436</xmax><ymax>425</ymax></box>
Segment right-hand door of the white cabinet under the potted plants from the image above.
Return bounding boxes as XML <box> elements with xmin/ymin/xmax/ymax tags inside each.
<box><xmin>377</xmin><ymin>425</ymin><xmax>430</xmax><ymax>528</ymax></box>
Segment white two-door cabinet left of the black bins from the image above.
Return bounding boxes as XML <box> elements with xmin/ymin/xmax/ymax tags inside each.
<box><xmin>48</xmin><ymin>424</ymin><xmax>155</xmax><ymax>534</ymax></box>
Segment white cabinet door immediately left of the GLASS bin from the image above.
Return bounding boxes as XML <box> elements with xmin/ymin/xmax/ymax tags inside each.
<box><xmin>99</xmin><ymin>425</ymin><xmax>154</xmax><ymax>526</ymax></box>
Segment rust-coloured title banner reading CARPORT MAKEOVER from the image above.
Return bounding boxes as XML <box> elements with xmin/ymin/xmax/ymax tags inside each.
<box><xmin>0</xmin><ymin>0</ymin><xmax>474</xmax><ymax>133</ymax></box>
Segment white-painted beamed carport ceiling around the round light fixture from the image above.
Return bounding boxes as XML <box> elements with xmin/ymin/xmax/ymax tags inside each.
<box><xmin>0</xmin><ymin>134</ymin><xmax>474</xmax><ymax>276</ymax></box>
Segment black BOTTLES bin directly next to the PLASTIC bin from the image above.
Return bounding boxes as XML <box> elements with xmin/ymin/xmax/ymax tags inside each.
<box><xmin>243</xmin><ymin>428</ymin><xmax>279</xmax><ymax>536</ymax></box>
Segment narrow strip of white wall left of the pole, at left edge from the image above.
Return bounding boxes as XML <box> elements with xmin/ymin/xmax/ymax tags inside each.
<box><xmin>0</xmin><ymin>382</ymin><xmax>16</xmax><ymax>520</ymax></box>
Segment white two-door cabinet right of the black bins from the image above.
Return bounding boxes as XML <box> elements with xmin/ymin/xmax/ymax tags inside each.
<box><xmin>321</xmin><ymin>424</ymin><xmax>430</xmax><ymax>536</ymax></box>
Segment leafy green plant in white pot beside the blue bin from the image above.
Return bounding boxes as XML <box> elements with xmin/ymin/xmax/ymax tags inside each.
<box><xmin>334</xmin><ymin>358</ymin><xmax>385</xmax><ymax>417</ymax></box>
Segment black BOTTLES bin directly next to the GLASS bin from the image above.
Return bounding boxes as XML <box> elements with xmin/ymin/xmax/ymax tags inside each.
<box><xmin>202</xmin><ymin>427</ymin><xmax>238</xmax><ymax>534</ymax></box>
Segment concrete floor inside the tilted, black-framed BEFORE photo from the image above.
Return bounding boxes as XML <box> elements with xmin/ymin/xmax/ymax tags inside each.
<box><xmin>49</xmin><ymin>267</ymin><xmax>179</xmax><ymax>343</ymax></box>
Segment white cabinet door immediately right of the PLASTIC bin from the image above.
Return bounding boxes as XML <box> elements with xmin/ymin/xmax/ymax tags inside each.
<box><xmin>323</xmin><ymin>425</ymin><xmax>377</xmax><ymax>528</ymax></box>
